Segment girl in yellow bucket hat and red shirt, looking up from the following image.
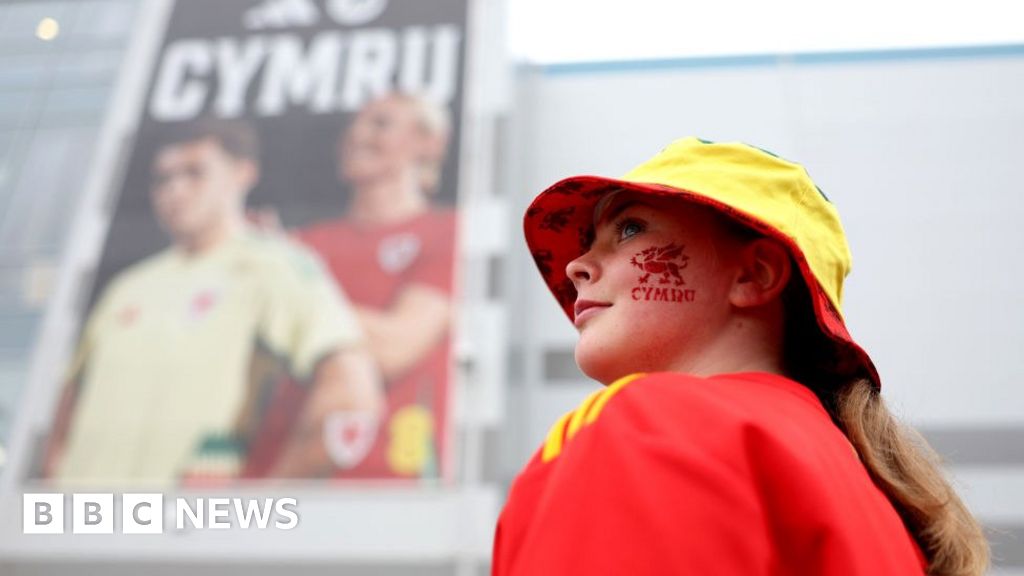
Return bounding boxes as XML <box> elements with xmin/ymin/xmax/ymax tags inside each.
<box><xmin>493</xmin><ymin>138</ymin><xmax>988</xmax><ymax>576</ymax></box>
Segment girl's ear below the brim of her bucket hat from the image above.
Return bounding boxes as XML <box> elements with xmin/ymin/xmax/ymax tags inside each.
<box><xmin>729</xmin><ymin>238</ymin><xmax>793</xmax><ymax>307</ymax></box>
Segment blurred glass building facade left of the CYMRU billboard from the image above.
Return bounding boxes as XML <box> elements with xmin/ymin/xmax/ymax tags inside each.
<box><xmin>0</xmin><ymin>0</ymin><xmax>137</xmax><ymax>475</ymax></box>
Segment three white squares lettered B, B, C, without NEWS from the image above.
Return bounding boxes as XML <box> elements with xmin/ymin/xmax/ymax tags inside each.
<box><xmin>22</xmin><ymin>494</ymin><xmax>164</xmax><ymax>534</ymax></box>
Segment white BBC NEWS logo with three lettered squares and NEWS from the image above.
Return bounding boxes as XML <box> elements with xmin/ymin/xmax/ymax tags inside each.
<box><xmin>22</xmin><ymin>494</ymin><xmax>299</xmax><ymax>534</ymax></box>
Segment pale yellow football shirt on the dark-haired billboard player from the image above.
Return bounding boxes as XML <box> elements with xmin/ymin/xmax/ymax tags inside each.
<box><xmin>56</xmin><ymin>231</ymin><xmax>361</xmax><ymax>486</ymax></box>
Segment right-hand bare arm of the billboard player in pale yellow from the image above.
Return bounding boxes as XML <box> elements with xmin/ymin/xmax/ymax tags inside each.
<box><xmin>270</xmin><ymin>345</ymin><xmax>384</xmax><ymax>478</ymax></box>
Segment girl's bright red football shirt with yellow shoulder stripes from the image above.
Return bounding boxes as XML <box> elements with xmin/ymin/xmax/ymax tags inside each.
<box><xmin>493</xmin><ymin>373</ymin><xmax>924</xmax><ymax>576</ymax></box>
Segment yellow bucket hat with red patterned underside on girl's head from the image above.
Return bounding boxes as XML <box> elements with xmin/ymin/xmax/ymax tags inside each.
<box><xmin>523</xmin><ymin>137</ymin><xmax>881</xmax><ymax>387</ymax></box>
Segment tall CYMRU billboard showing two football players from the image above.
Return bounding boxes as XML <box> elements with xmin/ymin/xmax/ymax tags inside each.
<box><xmin>38</xmin><ymin>0</ymin><xmax>467</xmax><ymax>486</ymax></box>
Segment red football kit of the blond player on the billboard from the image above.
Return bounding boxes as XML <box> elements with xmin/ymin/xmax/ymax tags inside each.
<box><xmin>298</xmin><ymin>209</ymin><xmax>456</xmax><ymax>479</ymax></box>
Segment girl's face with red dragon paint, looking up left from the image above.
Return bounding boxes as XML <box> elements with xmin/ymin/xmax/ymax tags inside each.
<box><xmin>566</xmin><ymin>192</ymin><xmax>738</xmax><ymax>384</ymax></box>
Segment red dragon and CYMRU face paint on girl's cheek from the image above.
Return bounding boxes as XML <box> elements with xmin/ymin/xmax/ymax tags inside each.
<box><xmin>630</xmin><ymin>242</ymin><xmax>696</xmax><ymax>303</ymax></box>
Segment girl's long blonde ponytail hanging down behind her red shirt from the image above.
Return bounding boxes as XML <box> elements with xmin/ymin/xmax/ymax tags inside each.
<box><xmin>783</xmin><ymin>277</ymin><xmax>989</xmax><ymax>576</ymax></box>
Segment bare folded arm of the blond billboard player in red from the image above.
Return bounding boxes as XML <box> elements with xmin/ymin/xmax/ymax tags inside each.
<box><xmin>356</xmin><ymin>284</ymin><xmax>452</xmax><ymax>380</ymax></box>
